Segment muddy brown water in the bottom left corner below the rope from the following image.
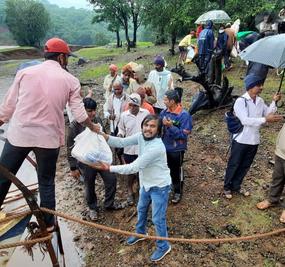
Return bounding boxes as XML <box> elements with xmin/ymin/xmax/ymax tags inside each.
<box><xmin>6</xmin><ymin>218</ymin><xmax>83</xmax><ymax>267</ymax></box>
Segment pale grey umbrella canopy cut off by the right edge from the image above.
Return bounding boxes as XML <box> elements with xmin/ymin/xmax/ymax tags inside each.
<box><xmin>240</xmin><ymin>33</ymin><xmax>285</xmax><ymax>68</ymax></box>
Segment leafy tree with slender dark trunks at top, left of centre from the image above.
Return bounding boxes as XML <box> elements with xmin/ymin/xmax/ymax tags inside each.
<box><xmin>89</xmin><ymin>0</ymin><xmax>144</xmax><ymax>51</ymax></box>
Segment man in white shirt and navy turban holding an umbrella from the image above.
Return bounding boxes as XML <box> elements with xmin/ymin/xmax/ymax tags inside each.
<box><xmin>224</xmin><ymin>74</ymin><xmax>283</xmax><ymax>199</ymax></box>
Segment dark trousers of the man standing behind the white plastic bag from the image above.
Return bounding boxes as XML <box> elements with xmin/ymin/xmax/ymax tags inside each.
<box><xmin>83</xmin><ymin>165</ymin><xmax>117</xmax><ymax>210</ymax></box>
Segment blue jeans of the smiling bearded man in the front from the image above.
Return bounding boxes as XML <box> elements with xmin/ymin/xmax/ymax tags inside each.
<box><xmin>136</xmin><ymin>185</ymin><xmax>170</xmax><ymax>250</ymax></box>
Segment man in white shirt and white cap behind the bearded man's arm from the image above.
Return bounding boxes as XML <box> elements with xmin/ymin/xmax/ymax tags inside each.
<box><xmin>117</xmin><ymin>93</ymin><xmax>149</xmax><ymax>205</ymax></box>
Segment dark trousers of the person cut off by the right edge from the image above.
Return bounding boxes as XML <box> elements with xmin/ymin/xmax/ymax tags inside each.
<box><xmin>269</xmin><ymin>155</ymin><xmax>285</xmax><ymax>207</ymax></box>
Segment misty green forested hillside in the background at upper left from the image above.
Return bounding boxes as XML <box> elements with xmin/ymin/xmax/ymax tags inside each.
<box><xmin>0</xmin><ymin>0</ymin><xmax>149</xmax><ymax>45</ymax></box>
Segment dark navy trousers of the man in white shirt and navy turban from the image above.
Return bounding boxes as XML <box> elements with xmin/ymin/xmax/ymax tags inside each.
<box><xmin>224</xmin><ymin>140</ymin><xmax>258</xmax><ymax>191</ymax></box>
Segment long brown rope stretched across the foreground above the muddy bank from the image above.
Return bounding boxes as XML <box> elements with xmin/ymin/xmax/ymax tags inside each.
<box><xmin>41</xmin><ymin>208</ymin><xmax>285</xmax><ymax>244</ymax></box>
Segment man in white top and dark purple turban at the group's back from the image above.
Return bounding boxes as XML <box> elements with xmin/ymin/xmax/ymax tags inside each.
<box><xmin>147</xmin><ymin>56</ymin><xmax>173</xmax><ymax>114</ymax></box>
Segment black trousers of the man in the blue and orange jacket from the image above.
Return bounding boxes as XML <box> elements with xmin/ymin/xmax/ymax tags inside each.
<box><xmin>166</xmin><ymin>151</ymin><xmax>184</xmax><ymax>194</ymax></box>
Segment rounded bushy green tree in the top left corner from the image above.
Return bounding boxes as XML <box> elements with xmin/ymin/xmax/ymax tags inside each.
<box><xmin>5</xmin><ymin>0</ymin><xmax>49</xmax><ymax>47</ymax></box>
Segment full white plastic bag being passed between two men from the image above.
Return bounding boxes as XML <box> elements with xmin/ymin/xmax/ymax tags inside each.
<box><xmin>71</xmin><ymin>128</ymin><xmax>113</xmax><ymax>164</ymax></box>
